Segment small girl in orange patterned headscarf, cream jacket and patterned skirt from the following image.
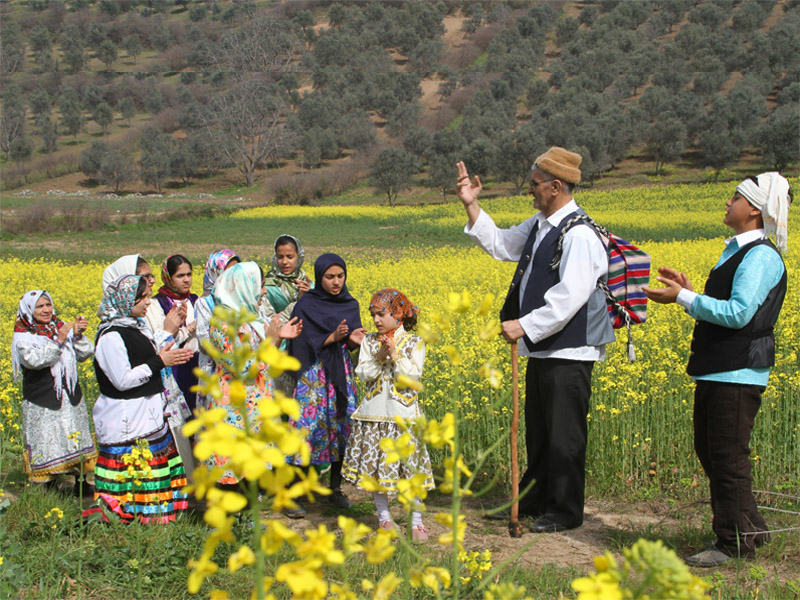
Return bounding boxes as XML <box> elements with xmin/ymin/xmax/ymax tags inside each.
<box><xmin>342</xmin><ymin>288</ymin><xmax>434</xmax><ymax>541</ymax></box>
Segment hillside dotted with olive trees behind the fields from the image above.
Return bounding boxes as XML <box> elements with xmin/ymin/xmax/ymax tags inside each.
<box><xmin>0</xmin><ymin>0</ymin><xmax>800</xmax><ymax>216</ymax></box>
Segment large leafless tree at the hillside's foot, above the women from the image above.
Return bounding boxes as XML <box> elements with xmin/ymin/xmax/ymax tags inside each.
<box><xmin>200</xmin><ymin>79</ymin><xmax>289</xmax><ymax>186</ymax></box>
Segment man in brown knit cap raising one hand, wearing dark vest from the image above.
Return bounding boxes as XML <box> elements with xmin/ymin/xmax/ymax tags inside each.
<box><xmin>457</xmin><ymin>147</ymin><xmax>614</xmax><ymax>533</ymax></box>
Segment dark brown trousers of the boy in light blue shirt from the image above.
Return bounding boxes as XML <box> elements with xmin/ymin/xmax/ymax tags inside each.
<box><xmin>694</xmin><ymin>380</ymin><xmax>769</xmax><ymax>558</ymax></box>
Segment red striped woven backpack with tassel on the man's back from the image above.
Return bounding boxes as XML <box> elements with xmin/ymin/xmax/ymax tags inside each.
<box><xmin>550</xmin><ymin>213</ymin><xmax>650</xmax><ymax>362</ymax></box>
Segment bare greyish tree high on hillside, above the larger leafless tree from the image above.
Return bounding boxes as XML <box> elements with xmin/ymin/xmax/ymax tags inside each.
<box><xmin>209</xmin><ymin>17</ymin><xmax>303</xmax><ymax>80</ymax></box>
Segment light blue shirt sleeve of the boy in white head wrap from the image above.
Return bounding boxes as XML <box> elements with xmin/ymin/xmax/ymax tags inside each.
<box><xmin>687</xmin><ymin>245</ymin><xmax>784</xmax><ymax>329</ymax></box>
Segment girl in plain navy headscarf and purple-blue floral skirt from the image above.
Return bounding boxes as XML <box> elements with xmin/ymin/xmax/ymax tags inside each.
<box><xmin>289</xmin><ymin>254</ymin><xmax>366</xmax><ymax>516</ymax></box>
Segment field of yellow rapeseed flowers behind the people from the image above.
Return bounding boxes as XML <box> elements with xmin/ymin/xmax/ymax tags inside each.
<box><xmin>0</xmin><ymin>181</ymin><xmax>800</xmax><ymax>493</ymax></box>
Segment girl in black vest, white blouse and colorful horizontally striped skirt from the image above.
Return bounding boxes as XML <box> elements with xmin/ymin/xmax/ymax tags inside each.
<box><xmin>90</xmin><ymin>275</ymin><xmax>192</xmax><ymax>523</ymax></box>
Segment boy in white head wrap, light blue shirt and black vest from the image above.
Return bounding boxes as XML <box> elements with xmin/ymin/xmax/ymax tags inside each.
<box><xmin>645</xmin><ymin>172</ymin><xmax>792</xmax><ymax>567</ymax></box>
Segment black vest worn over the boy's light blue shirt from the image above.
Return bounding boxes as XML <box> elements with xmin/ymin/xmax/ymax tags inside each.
<box><xmin>686</xmin><ymin>239</ymin><xmax>786</xmax><ymax>376</ymax></box>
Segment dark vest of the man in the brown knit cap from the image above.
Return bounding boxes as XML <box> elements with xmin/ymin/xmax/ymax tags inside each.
<box><xmin>500</xmin><ymin>208</ymin><xmax>615</xmax><ymax>352</ymax></box>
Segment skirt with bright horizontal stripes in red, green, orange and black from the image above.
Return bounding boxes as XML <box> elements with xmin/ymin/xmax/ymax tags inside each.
<box><xmin>94</xmin><ymin>428</ymin><xmax>188</xmax><ymax>523</ymax></box>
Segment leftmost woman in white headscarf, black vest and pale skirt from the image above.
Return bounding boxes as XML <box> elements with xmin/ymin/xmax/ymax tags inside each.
<box><xmin>11</xmin><ymin>290</ymin><xmax>97</xmax><ymax>493</ymax></box>
